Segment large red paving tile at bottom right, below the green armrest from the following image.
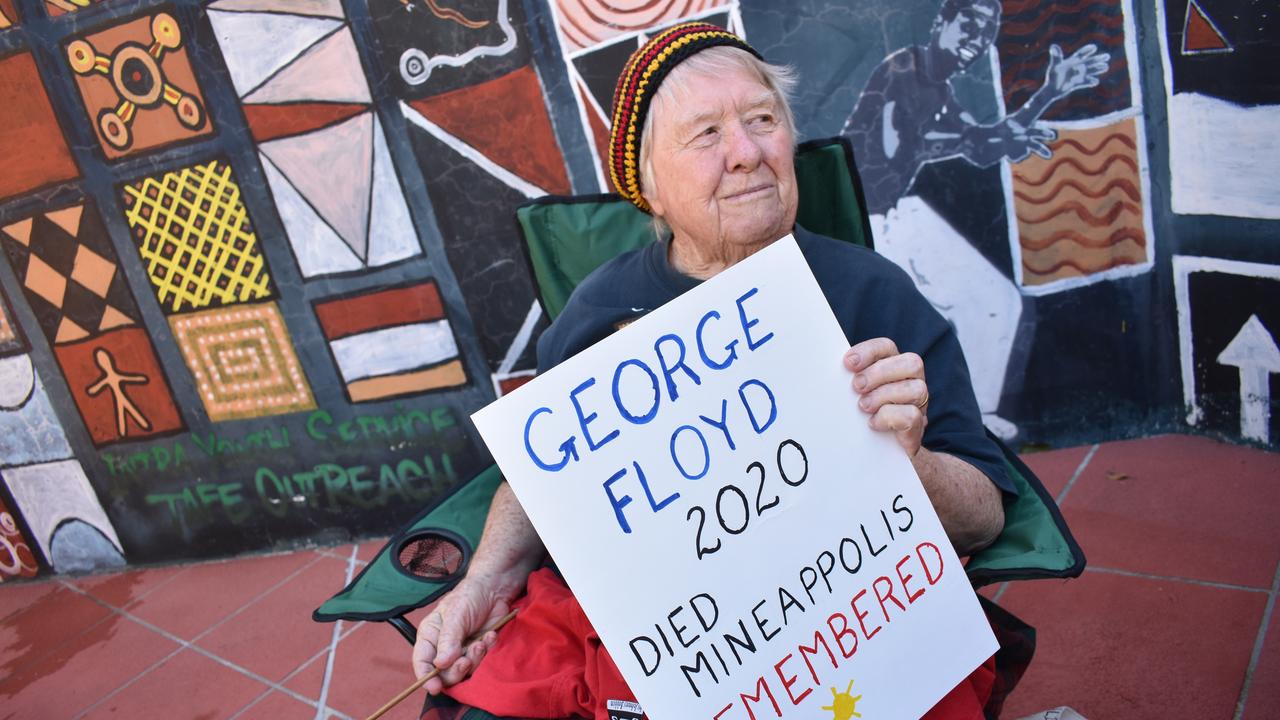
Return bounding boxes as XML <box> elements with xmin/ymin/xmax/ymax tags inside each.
<box><xmin>1001</xmin><ymin>568</ymin><xmax>1267</xmax><ymax>720</ymax></box>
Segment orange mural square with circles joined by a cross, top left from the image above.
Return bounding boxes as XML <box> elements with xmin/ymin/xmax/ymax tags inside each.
<box><xmin>64</xmin><ymin>10</ymin><xmax>214</xmax><ymax>160</ymax></box>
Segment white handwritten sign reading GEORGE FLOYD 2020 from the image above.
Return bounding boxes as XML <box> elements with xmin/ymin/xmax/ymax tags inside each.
<box><xmin>474</xmin><ymin>237</ymin><xmax>997</xmax><ymax>720</ymax></box>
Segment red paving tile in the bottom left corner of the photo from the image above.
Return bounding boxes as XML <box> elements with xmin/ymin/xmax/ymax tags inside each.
<box><xmin>0</xmin><ymin>607</ymin><xmax>179</xmax><ymax>717</ymax></box>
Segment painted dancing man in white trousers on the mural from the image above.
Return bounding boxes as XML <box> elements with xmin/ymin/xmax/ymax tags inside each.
<box><xmin>844</xmin><ymin>0</ymin><xmax>1111</xmax><ymax>439</ymax></box>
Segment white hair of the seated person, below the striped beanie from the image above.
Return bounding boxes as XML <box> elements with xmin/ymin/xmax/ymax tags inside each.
<box><xmin>639</xmin><ymin>45</ymin><xmax>797</xmax><ymax>238</ymax></box>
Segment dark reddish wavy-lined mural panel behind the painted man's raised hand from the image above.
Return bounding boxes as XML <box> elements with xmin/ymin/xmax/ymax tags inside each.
<box><xmin>996</xmin><ymin>0</ymin><xmax>1133</xmax><ymax>120</ymax></box>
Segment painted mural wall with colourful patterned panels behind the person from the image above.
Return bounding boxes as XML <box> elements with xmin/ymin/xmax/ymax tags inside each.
<box><xmin>0</xmin><ymin>0</ymin><xmax>1280</xmax><ymax>580</ymax></box>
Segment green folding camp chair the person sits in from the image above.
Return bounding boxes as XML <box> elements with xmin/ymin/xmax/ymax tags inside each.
<box><xmin>312</xmin><ymin>138</ymin><xmax>1084</xmax><ymax>717</ymax></box>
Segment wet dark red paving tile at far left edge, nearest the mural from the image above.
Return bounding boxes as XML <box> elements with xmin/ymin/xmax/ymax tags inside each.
<box><xmin>0</xmin><ymin>585</ymin><xmax>111</xmax><ymax>680</ymax></box>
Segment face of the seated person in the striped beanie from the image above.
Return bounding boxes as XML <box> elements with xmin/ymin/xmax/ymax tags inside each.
<box><xmin>644</xmin><ymin>68</ymin><xmax>797</xmax><ymax>264</ymax></box>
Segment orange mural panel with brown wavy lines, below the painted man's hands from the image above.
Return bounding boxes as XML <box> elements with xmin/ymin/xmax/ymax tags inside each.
<box><xmin>1012</xmin><ymin>118</ymin><xmax>1148</xmax><ymax>286</ymax></box>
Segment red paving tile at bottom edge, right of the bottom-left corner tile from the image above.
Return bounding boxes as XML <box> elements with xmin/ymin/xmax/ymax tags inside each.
<box><xmin>84</xmin><ymin>650</ymin><xmax>268</xmax><ymax>720</ymax></box>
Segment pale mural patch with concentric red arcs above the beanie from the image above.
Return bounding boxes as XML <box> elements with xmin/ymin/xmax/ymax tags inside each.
<box><xmin>556</xmin><ymin>0</ymin><xmax>731</xmax><ymax>53</ymax></box>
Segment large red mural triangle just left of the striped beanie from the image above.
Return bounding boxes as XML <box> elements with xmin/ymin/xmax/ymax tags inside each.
<box><xmin>410</xmin><ymin>65</ymin><xmax>572</xmax><ymax>195</ymax></box>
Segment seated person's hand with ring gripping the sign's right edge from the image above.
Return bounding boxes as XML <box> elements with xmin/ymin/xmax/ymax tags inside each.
<box><xmin>845</xmin><ymin>337</ymin><xmax>929</xmax><ymax>457</ymax></box>
